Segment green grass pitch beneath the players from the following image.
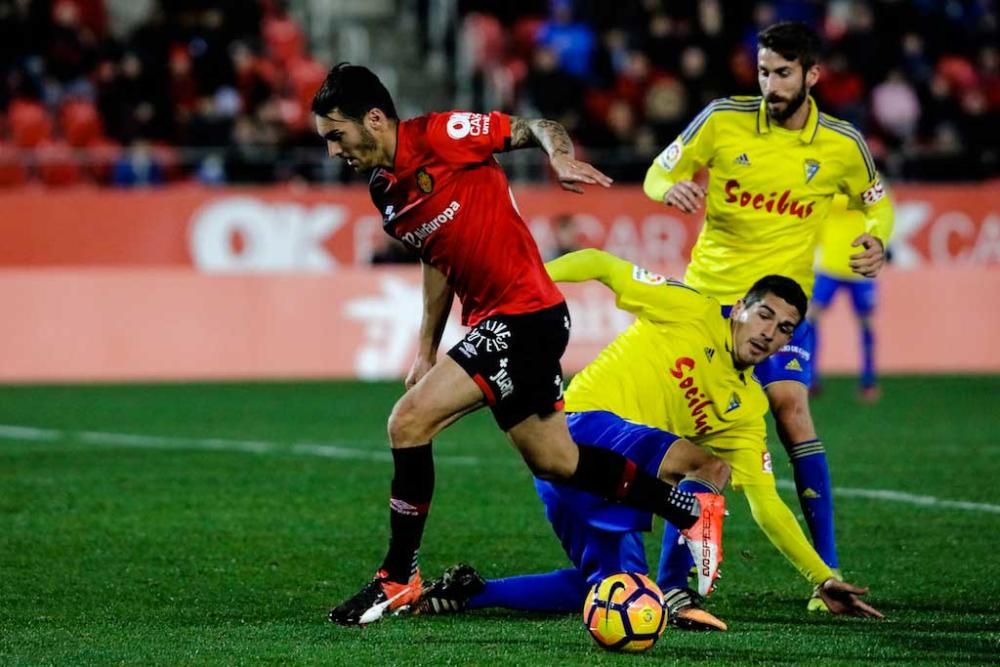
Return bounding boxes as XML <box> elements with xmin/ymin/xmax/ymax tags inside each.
<box><xmin>0</xmin><ymin>377</ymin><xmax>1000</xmax><ymax>667</ymax></box>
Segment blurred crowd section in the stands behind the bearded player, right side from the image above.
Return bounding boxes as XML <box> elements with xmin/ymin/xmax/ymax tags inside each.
<box><xmin>462</xmin><ymin>0</ymin><xmax>1000</xmax><ymax>180</ymax></box>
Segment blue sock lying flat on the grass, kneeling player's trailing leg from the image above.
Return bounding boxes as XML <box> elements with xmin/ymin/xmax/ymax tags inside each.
<box><xmin>466</xmin><ymin>569</ymin><xmax>590</xmax><ymax>612</ymax></box>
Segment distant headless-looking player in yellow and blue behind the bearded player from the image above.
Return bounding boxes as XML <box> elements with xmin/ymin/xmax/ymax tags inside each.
<box><xmin>808</xmin><ymin>196</ymin><xmax>880</xmax><ymax>403</ymax></box>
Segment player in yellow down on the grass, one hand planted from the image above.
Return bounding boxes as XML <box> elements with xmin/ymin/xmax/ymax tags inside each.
<box><xmin>420</xmin><ymin>250</ymin><xmax>880</xmax><ymax>630</ymax></box>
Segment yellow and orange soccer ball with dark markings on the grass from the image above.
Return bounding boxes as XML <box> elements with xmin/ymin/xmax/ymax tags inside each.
<box><xmin>583</xmin><ymin>572</ymin><xmax>667</xmax><ymax>653</ymax></box>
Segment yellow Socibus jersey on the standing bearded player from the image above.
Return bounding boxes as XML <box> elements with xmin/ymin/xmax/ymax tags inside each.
<box><xmin>643</xmin><ymin>97</ymin><xmax>893</xmax><ymax>305</ymax></box>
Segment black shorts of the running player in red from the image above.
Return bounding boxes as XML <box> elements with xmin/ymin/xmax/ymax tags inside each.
<box><xmin>448</xmin><ymin>303</ymin><xmax>570</xmax><ymax>431</ymax></box>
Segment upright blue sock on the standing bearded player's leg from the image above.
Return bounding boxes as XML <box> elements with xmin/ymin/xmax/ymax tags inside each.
<box><xmin>788</xmin><ymin>440</ymin><xmax>838</xmax><ymax>568</ymax></box>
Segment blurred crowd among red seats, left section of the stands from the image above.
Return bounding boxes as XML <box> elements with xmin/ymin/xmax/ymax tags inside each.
<box><xmin>0</xmin><ymin>0</ymin><xmax>328</xmax><ymax>186</ymax></box>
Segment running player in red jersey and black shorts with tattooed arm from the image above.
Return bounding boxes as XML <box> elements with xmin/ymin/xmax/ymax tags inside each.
<box><xmin>312</xmin><ymin>63</ymin><xmax>723</xmax><ymax>625</ymax></box>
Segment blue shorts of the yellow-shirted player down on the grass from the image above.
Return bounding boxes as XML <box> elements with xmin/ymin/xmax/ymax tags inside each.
<box><xmin>535</xmin><ymin>411</ymin><xmax>677</xmax><ymax>584</ymax></box>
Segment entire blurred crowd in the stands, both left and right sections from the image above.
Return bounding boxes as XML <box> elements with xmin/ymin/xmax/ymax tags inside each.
<box><xmin>0</xmin><ymin>0</ymin><xmax>1000</xmax><ymax>186</ymax></box>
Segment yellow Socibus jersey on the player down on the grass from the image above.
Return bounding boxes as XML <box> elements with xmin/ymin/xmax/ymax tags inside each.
<box><xmin>546</xmin><ymin>250</ymin><xmax>768</xmax><ymax>452</ymax></box>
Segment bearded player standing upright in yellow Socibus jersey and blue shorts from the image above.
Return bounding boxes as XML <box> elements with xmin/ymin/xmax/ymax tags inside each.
<box><xmin>643</xmin><ymin>23</ymin><xmax>893</xmax><ymax>610</ymax></box>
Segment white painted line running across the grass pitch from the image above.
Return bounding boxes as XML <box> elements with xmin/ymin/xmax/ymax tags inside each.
<box><xmin>0</xmin><ymin>424</ymin><xmax>1000</xmax><ymax>514</ymax></box>
